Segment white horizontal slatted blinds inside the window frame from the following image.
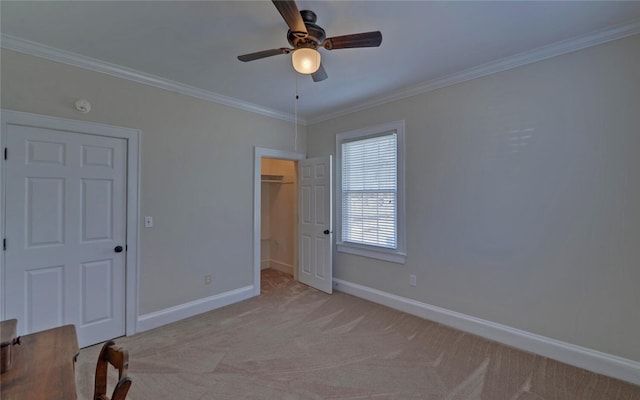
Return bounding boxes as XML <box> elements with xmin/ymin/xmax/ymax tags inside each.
<box><xmin>341</xmin><ymin>132</ymin><xmax>398</xmax><ymax>249</ymax></box>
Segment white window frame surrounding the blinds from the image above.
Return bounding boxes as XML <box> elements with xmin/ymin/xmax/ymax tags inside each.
<box><xmin>335</xmin><ymin>121</ymin><xmax>407</xmax><ymax>264</ymax></box>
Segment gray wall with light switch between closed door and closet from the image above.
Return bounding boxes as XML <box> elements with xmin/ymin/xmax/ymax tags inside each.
<box><xmin>1</xmin><ymin>50</ymin><xmax>306</xmax><ymax>315</ymax></box>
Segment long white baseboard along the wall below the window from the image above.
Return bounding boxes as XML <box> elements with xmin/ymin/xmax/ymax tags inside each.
<box><xmin>333</xmin><ymin>279</ymin><xmax>640</xmax><ymax>385</ymax></box>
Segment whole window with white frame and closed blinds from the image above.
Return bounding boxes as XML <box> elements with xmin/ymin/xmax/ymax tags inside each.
<box><xmin>336</xmin><ymin>121</ymin><xmax>406</xmax><ymax>263</ymax></box>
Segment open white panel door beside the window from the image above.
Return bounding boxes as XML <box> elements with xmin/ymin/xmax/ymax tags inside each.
<box><xmin>298</xmin><ymin>156</ymin><xmax>333</xmax><ymax>293</ymax></box>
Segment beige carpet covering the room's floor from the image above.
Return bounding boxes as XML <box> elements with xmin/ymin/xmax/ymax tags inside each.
<box><xmin>76</xmin><ymin>270</ymin><xmax>640</xmax><ymax>400</ymax></box>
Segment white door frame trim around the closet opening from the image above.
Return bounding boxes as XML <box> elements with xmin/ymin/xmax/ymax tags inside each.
<box><xmin>253</xmin><ymin>147</ymin><xmax>307</xmax><ymax>296</ymax></box>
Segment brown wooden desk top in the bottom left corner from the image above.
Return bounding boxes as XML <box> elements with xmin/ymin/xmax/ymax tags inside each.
<box><xmin>0</xmin><ymin>325</ymin><xmax>78</xmax><ymax>400</ymax></box>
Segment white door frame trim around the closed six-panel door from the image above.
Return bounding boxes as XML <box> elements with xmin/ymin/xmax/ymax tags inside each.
<box><xmin>0</xmin><ymin>109</ymin><xmax>142</xmax><ymax>336</ymax></box>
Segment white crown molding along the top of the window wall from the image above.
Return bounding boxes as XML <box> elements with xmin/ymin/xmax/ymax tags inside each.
<box><xmin>307</xmin><ymin>20</ymin><xmax>640</xmax><ymax>125</ymax></box>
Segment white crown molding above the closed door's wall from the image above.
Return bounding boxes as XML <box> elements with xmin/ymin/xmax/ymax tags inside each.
<box><xmin>0</xmin><ymin>33</ymin><xmax>306</xmax><ymax>125</ymax></box>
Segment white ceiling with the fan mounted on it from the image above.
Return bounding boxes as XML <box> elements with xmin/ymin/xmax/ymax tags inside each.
<box><xmin>0</xmin><ymin>0</ymin><xmax>640</xmax><ymax>122</ymax></box>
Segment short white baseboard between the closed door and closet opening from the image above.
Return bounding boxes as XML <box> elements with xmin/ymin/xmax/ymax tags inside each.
<box><xmin>137</xmin><ymin>285</ymin><xmax>253</xmax><ymax>332</ymax></box>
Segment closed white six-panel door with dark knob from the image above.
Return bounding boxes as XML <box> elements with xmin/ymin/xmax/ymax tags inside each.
<box><xmin>3</xmin><ymin>125</ymin><xmax>126</xmax><ymax>347</ymax></box>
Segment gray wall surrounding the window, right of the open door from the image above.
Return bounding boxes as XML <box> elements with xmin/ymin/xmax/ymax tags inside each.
<box><xmin>308</xmin><ymin>35</ymin><xmax>640</xmax><ymax>361</ymax></box>
